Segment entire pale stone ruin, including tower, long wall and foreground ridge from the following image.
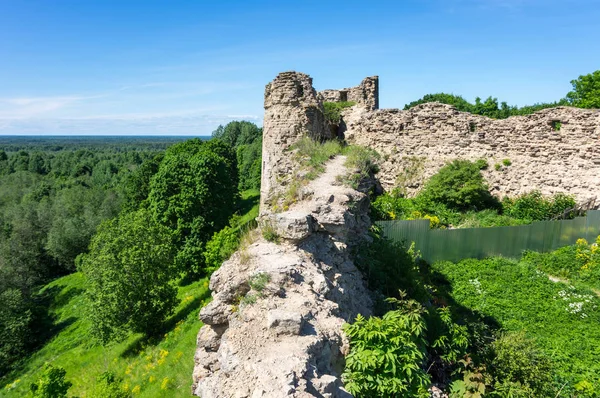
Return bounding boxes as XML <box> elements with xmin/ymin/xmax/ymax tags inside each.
<box><xmin>192</xmin><ymin>72</ymin><xmax>600</xmax><ymax>398</ymax></box>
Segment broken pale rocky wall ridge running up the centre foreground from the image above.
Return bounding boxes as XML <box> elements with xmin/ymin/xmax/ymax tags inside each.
<box><xmin>193</xmin><ymin>156</ymin><xmax>372</xmax><ymax>398</ymax></box>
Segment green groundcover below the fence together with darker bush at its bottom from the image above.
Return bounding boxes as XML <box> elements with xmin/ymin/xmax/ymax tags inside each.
<box><xmin>433</xmin><ymin>258</ymin><xmax>600</xmax><ymax>397</ymax></box>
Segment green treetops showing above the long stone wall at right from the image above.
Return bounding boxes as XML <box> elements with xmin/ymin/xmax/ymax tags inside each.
<box><xmin>404</xmin><ymin>70</ymin><xmax>600</xmax><ymax>119</ymax></box>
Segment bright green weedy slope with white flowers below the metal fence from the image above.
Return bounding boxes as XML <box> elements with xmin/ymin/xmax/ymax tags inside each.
<box><xmin>433</xmin><ymin>258</ymin><xmax>600</xmax><ymax>396</ymax></box>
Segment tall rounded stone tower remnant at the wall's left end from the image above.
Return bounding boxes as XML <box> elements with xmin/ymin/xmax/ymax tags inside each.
<box><xmin>260</xmin><ymin>72</ymin><xmax>332</xmax><ymax>214</ymax></box>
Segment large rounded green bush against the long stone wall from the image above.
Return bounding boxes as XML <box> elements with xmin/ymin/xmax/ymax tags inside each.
<box><xmin>420</xmin><ymin>160</ymin><xmax>498</xmax><ymax>210</ymax></box>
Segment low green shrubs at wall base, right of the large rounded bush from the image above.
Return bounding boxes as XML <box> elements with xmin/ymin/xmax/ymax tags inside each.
<box><xmin>502</xmin><ymin>191</ymin><xmax>576</xmax><ymax>221</ymax></box>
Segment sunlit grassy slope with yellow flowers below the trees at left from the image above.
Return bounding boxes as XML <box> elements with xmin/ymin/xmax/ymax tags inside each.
<box><xmin>0</xmin><ymin>273</ymin><xmax>209</xmax><ymax>397</ymax></box>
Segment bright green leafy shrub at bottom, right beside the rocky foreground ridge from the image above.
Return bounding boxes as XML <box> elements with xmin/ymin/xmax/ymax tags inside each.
<box><xmin>342</xmin><ymin>294</ymin><xmax>430</xmax><ymax>397</ymax></box>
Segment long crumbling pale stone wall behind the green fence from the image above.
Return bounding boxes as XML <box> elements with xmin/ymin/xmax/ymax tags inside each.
<box><xmin>343</xmin><ymin>103</ymin><xmax>600</xmax><ymax>202</ymax></box>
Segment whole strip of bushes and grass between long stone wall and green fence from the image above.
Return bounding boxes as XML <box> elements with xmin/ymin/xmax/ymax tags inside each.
<box><xmin>371</xmin><ymin>160</ymin><xmax>576</xmax><ymax>228</ymax></box>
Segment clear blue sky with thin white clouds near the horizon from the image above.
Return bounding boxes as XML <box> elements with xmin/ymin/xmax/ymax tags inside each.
<box><xmin>0</xmin><ymin>0</ymin><xmax>600</xmax><ymax>135</ymax></box>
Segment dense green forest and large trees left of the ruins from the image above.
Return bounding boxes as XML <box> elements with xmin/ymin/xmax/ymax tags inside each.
<box><xmin>0</xmin><ymin>122</ymin><xmax>262</xmax><ymax>376</ymax></box>
